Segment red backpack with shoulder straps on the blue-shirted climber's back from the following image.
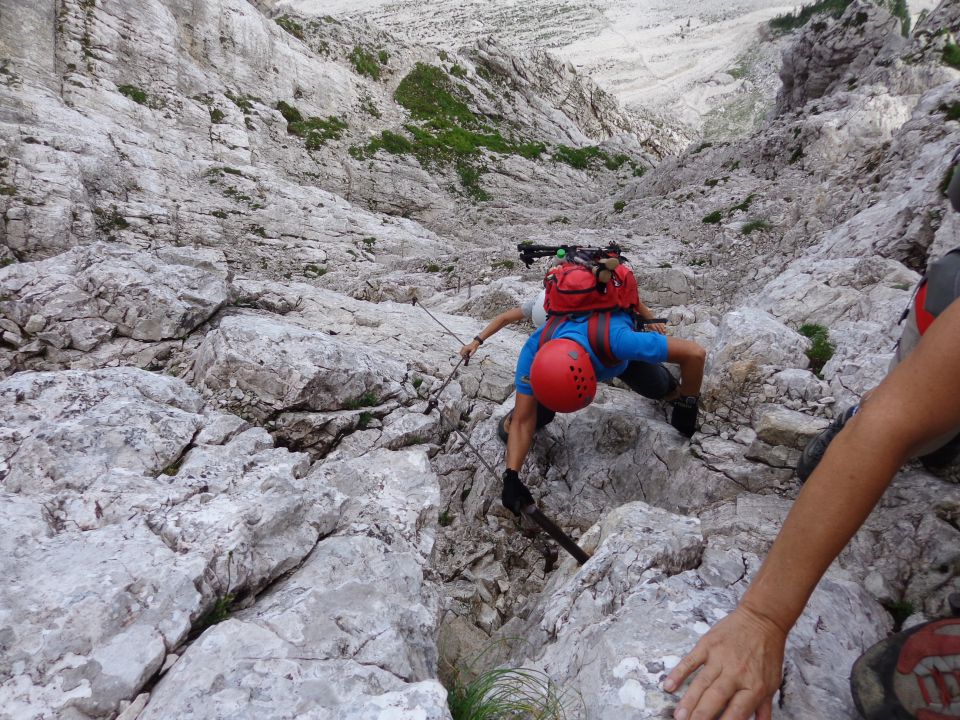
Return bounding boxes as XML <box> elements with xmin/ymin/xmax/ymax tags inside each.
<box><xmin>539</xmin><ymin>244</ymin><xmax>640</xmax><ymax>367</ymax></box>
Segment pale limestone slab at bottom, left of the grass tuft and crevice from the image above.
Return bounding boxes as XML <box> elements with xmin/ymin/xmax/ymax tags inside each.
<box><xmin>139</xmin><ymin>450</ymin><xmax>450</xmax><ymax>720</ymax></box>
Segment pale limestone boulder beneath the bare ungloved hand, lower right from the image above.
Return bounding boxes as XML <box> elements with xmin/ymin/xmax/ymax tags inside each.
<box><xmin>516</xmin><ymin>503</ymin><xmax>883</xmax><ymax>720</ymax></box>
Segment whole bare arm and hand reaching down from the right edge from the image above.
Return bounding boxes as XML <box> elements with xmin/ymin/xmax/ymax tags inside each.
<box><xmin>664</xmin><ymin>299</ymin><xmax>960</xmax><ymax>720</ymax></box>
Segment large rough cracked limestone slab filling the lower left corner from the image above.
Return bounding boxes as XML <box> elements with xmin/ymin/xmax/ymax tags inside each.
<box><xmin>0</xmin><ymin>368</ymin><xmax>337</xmax><ymax>717</ymax></box>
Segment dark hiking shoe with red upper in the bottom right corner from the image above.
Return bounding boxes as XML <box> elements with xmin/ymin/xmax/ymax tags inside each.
<box><xmin>850</xmin><ymin>618</ymin><xmax>960</xmax><ymax>720</ymax></box>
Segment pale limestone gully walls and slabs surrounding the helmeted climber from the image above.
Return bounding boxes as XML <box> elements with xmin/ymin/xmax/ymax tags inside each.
<box><xmin>0</xmin><ymin>0</ymin><xmax>960</xmax><ymax>720</ymax></box>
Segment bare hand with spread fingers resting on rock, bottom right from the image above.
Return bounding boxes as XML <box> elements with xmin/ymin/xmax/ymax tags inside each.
<box><xmin>663</xmin><ymin>606</ymin><xmax>787</xmax><ymax>720</ymax></box>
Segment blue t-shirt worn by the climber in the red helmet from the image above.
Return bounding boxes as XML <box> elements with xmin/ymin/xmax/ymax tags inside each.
<box><xmin>513</xmin><ymin>313</ymin><xmax>667</xmax><ymax>395</ymax></box>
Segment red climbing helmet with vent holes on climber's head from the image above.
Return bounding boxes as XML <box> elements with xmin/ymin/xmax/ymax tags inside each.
<box><xmin>530</xmin><ymin>338</ymin><xmax>597</xmax><ymax>412</ymax></box>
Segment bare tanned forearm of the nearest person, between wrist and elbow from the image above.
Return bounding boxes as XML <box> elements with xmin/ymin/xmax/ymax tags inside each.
<box><xmin>742</xmin><ymin>413</ymin><xmax>906</xmax><ymax>633</ymax></box>
